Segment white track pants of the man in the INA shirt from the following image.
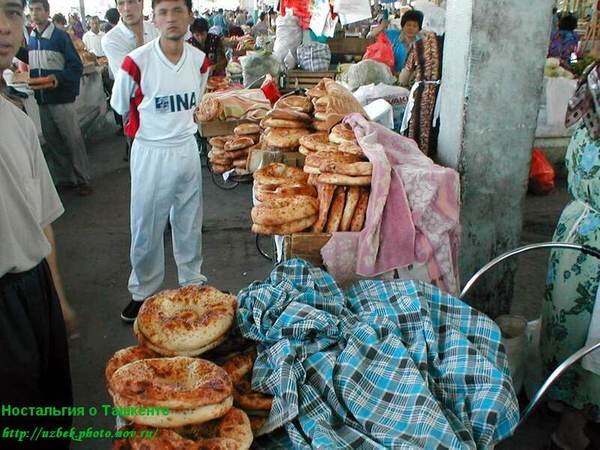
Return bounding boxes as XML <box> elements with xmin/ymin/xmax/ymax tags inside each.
<box><xmin>129</xmin><ymin>136</ymin><xmax>206</xmax><ymax>300</ymax></box>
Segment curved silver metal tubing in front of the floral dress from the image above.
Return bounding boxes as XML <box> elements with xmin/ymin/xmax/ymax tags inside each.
<box><xmin>459</xmin><ymin>242</ymin><xmax>600</xmax><ymax>426</ymax></box>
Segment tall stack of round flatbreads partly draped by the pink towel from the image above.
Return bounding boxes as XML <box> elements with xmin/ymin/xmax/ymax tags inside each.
<box><xmin>251</xmin><ymin>80</ymin><xmax>373</xmax><ymax>235</ymax></box>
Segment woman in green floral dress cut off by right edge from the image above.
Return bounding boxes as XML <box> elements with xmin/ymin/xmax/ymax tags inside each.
<box><xmin>540</xmin><ymin>62</ymin><xmax>600</xmax><ymax>449</ymax></box>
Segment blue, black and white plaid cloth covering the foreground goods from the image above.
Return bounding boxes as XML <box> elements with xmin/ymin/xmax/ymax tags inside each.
<box><xmin>237</xmin><ymin>259</ymin><xmax>519</xmax><ymax>449</ymax></box>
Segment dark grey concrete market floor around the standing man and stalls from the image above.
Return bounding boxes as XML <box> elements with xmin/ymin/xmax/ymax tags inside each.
<box><xmin>55</xmin><ymin>125</ymin><xmax>600</xmax><ymax>450</ymax></box>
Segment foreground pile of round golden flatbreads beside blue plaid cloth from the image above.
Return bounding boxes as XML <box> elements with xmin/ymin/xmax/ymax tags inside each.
<box><xmin>105</xmin><ymin>286</ymin><xmax>272</xmax><ymax>450</ymax></box>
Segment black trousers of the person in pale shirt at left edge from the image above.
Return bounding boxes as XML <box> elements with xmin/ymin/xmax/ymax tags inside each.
<box><xmin>0</xmin><ymin>260</ymin><xmax>73</xmax><ymax>450</ymax></box>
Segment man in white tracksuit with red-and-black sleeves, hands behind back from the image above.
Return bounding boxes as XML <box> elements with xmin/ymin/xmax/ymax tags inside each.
<box><xmin>111</xmin><ymin>0</ymin><xmax>209</xmax><ymax>322</ymax></box>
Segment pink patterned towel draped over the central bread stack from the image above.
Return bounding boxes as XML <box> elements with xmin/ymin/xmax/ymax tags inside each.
<box><xmin>321</xmin><ymin>114</ymin><xmax>460</xmax><ymax>294</ymax></box>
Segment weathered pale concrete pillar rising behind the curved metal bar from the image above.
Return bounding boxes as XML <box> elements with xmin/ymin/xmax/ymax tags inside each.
<box><xmin>438</xmin><ymin>0</ymin><xmax>554</xmax><ymax>316</ymax></box>
